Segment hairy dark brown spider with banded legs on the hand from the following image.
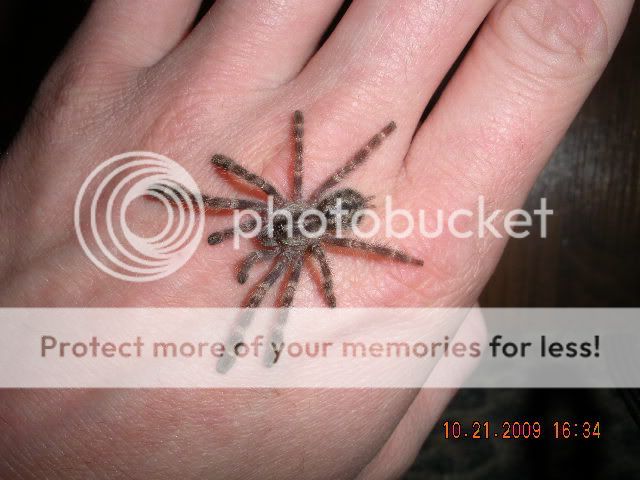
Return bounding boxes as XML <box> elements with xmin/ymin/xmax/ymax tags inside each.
<box><xmin>153</xmin><ymin>110</ymin><xmax>423</xmax><ymax>309</ymax></box>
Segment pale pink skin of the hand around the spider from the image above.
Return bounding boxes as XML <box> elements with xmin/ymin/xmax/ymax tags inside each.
<box><xmin>0</xmin><ymin>0</ymin><xmax>632</xmax><ymax>478</ymax></box>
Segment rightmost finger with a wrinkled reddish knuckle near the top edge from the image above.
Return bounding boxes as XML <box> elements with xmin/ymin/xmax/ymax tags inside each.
<box><xmin>404</xmin><ymin>0</ymin><xmax>632</xmax><ymax>298</ymax></box>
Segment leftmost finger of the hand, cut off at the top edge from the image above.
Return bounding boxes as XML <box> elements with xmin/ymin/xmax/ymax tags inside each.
<box><xmin>73</xmin><ymin>0</ymin><xmax>201</xmax><ymax>67</ymax></box>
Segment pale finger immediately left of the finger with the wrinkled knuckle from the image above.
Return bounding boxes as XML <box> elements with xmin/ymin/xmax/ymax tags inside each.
<box><xmin>297</xmin><ymin>0</ymin><xmax>495</xmax><ymax>129</ymax></box>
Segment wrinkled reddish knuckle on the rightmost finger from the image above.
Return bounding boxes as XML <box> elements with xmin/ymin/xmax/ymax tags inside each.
<box><xmin>489</xmin><ymin>0</ymin><xmax>609</xmax><ymax>78</ymax></box>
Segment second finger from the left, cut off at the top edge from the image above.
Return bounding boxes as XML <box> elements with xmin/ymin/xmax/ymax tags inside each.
<box><xmin>172</xmin><ymin>0</ymin><xmax>342</xmax><ymax>88</ymax></box>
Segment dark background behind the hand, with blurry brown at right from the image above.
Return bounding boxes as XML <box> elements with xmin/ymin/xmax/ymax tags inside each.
<box><xmin>0</xmin><ymin>0</ymin><xmax>640</xmax><ymax>479</ymax></box>
